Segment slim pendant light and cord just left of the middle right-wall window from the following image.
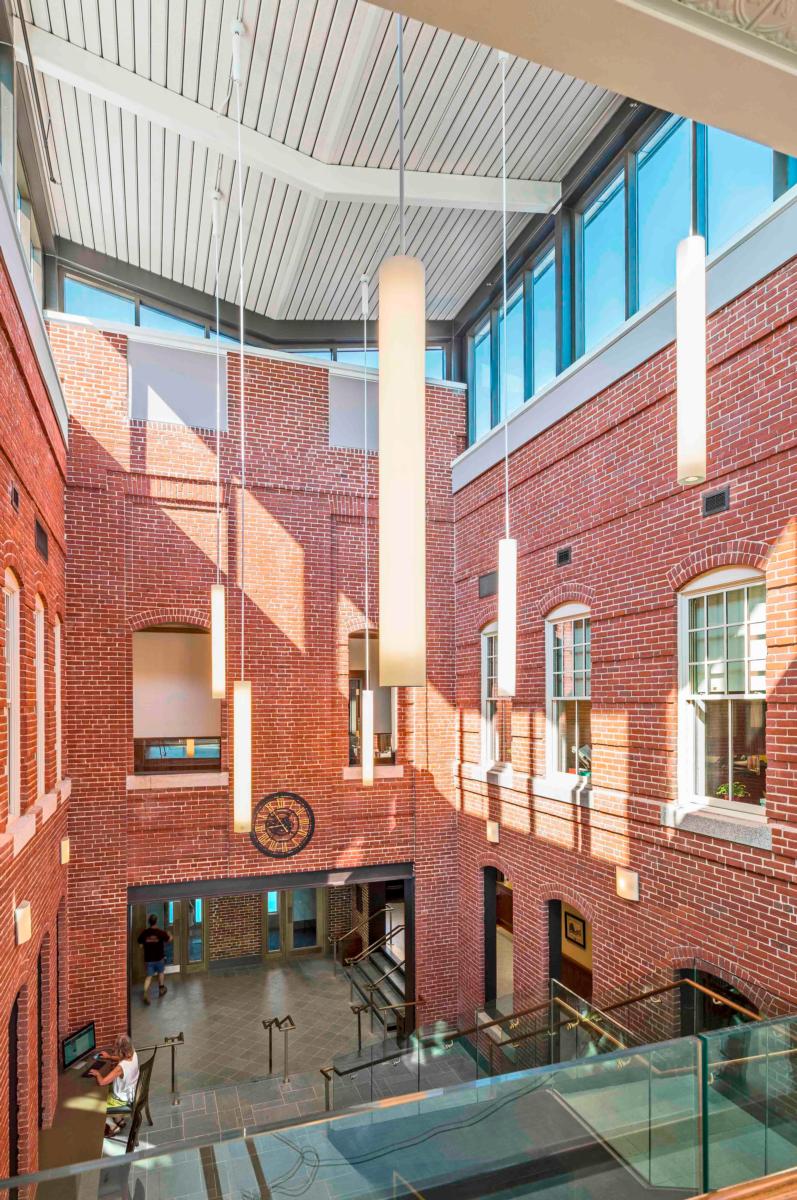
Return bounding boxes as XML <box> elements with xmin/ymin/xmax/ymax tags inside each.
<box><xmin>496</xmin><ymin>50</ymin><xmax>517</xmax><ymax>697</ymax></box>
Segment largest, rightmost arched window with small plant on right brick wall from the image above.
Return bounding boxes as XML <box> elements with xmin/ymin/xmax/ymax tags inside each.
<box><xmin>678</xmin><ymin>566</ymin><xmax>767</xmax><ymax>811</ymax></box>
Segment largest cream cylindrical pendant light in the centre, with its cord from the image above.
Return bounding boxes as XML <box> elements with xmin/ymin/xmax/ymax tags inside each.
<box><xmin>379</xmin><ymin>14</ymin><xmax>426</xmax><ymax>686</ymax></box>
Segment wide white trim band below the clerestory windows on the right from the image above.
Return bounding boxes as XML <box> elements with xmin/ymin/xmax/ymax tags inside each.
<box><xmin>451</xmin><ymin>187</ymin><xmax>797</xmax><ymax>492</ymax></box>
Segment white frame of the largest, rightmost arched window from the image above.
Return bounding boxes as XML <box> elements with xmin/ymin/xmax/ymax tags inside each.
<box><xmin>677</xmin><ymin>566</ymin><xmax>767</xmax><ymax>820</ymax></box>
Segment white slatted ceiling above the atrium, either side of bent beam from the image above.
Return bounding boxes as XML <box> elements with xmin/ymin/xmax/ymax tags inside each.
<box><xmin>28</xmin><ymin>0</ymin><xmax>618</xmax><ymax>319</ymax></box>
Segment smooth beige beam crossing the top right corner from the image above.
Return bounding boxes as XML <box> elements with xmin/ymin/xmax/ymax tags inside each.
<box><xmin>364</xmin><ymin>0</ymin><xmax>797</xmax><ymax>155</ymax></box>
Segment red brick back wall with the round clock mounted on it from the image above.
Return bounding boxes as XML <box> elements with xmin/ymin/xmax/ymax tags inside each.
<box><xmin>50</xmin><ymin>323</ymin><xmax>465</xmax><ymax>1037</ymax></box>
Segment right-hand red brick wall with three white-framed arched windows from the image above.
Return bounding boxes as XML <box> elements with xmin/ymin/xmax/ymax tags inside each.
<box><xmin>455</xmin><ymin>253</ymin><xmax>797</xmax><ymax>1022</ymax></box>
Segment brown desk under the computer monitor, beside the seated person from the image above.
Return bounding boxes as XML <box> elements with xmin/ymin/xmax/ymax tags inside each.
<box><xmin>37</xmin><ymin>1063</ymin><xmax>108</xmax><ymax>1200</ymax></box>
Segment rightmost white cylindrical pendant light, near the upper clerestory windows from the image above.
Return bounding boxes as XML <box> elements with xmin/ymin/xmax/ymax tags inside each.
<box><xmin>676</xmin><ymin>233</ymin><xmax>706</xmax><ymax>487</ymax></box>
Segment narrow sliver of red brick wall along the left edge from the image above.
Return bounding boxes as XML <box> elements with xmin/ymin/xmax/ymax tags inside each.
<box><xmin>0</xmin><ymin>248</ymin><xmax>70</xmax><ymax>1175</ymax></box>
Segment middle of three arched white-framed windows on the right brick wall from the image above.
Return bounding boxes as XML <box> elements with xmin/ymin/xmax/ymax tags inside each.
<box><xmin>545</xmin><ymin>602</ymin><xmax>592</xmax><ymax>780</ymax></box>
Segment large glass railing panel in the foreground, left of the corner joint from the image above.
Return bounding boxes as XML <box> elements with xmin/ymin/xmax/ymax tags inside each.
<box><xmin>0</xmin><ymin>1043</ymin><xmax>699</xmax><ymax>1200</ymax></box>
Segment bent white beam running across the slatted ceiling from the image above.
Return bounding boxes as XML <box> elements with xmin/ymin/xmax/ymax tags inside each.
<box><xmin>23</xmin><ymin>25</ymin><xmax>561</xmax><ymax>212</ymax></box>
